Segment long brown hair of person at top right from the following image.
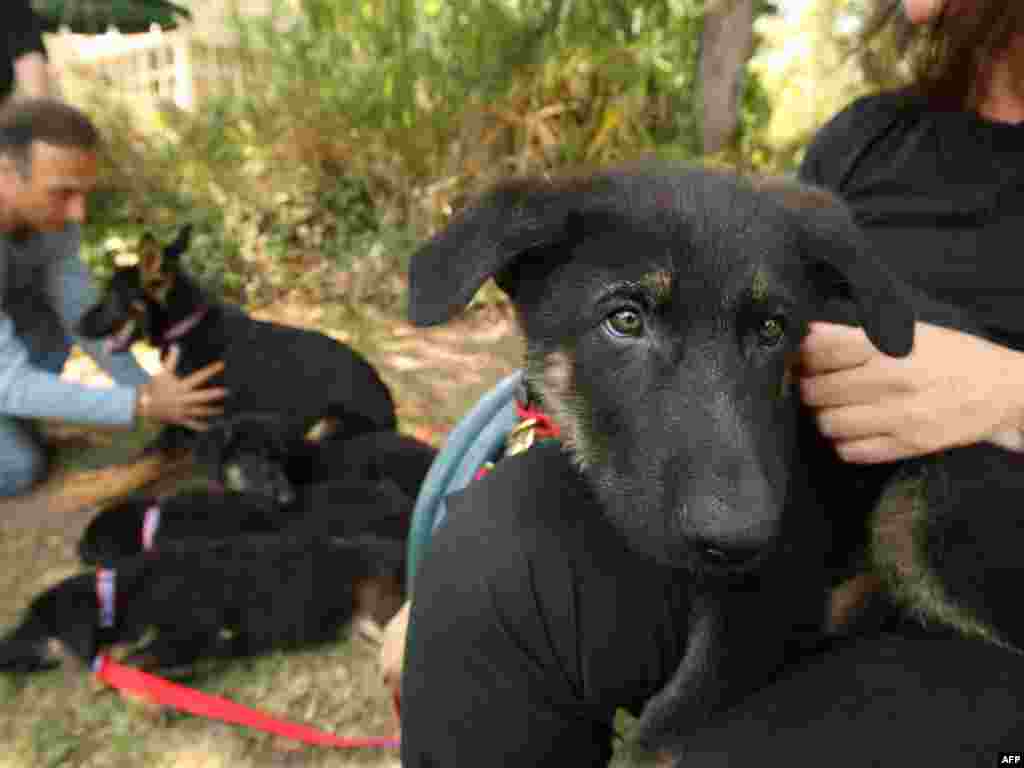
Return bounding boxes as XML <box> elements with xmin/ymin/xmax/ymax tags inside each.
<box><xmin>855</xmin><ymin>0</ymin><xmax>1024</xmax><ymax>110</ymax></box>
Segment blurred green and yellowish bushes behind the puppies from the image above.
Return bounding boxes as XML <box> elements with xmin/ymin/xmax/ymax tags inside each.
<box><xmin>68</xmin><ymin>0</ymin><xmax>768</xmax><ymax>317</ymax></box>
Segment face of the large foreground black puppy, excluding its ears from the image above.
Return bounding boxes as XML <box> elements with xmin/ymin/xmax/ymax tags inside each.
<box><xmin>514</xmin><ymin>206</ymin><xmax>813</xmax><ymax>570</ymax></box>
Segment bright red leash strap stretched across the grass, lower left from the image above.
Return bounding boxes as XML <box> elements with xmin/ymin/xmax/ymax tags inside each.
<box><xmin>93</xmin><ymin>655</ymin><xmax>399</xmax><ymax>749</ymax></box>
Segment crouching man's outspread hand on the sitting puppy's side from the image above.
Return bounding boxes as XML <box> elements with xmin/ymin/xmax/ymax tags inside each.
<box><xmin>135</xmin><ymin>345</ymin><xmax>227</xmax><ymax>432</ymax></box>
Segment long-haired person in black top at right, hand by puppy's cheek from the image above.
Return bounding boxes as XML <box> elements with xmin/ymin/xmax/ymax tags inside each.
<box><xmin>800</xmin><ymin>0</ymin><xmax>1024</xmax><ymax>463</ymax></box>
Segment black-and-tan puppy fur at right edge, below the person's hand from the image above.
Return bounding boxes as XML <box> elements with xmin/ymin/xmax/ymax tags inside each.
<box><xmin>869</xmin><ymin>443</ymin><xmax>1024</xmax><ymax>654</ymax></box>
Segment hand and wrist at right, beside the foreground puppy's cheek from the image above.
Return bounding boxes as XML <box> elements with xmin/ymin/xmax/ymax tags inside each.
<box><xmin>800</xmin><ymin>323</ymin><xmax>1024</xmax><ymax>464</ymax></box>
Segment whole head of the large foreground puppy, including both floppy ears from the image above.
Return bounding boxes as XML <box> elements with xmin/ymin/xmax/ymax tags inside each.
<box><xmin>411</xmin><ymin>162</ymin><xmax>913</xmax><ymax>571</ymax></box>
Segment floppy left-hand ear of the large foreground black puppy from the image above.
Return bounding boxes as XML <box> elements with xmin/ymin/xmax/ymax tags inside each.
<box><xmin>409</xmin><ymin>178</ymin><xmax>581</xmax><ymax>326</ymax></box>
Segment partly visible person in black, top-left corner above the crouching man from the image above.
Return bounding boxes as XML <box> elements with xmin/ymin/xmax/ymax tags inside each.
<box><xmin>0</xmin><ymin>0</ymin><xmax>56</xmax><ymax>103</ymax></box>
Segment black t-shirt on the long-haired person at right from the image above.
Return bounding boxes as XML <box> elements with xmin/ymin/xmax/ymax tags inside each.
<box><xmin>800</xmin><ymin>92</ymin><xmax>1024</xmax><ymax>349</ymax></box>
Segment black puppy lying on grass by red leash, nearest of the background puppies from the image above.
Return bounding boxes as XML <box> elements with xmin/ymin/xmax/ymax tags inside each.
<box><xmin>0</xmin><ymin>535</ymin><xmax>404</xmax><ymax>671</ymax></box>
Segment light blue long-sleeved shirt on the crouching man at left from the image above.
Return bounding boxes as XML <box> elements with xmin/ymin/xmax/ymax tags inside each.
<box><xmin>0</xmin><ymin>225</ymin><xmax>148</xmax><ymax>426</ymax></box>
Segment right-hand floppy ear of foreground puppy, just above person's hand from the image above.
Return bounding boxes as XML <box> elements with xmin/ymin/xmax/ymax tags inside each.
<box><xmin>761</xmin><ymin>179</ymin><xmax>915</xmax><ymax>357</ymax></box>
